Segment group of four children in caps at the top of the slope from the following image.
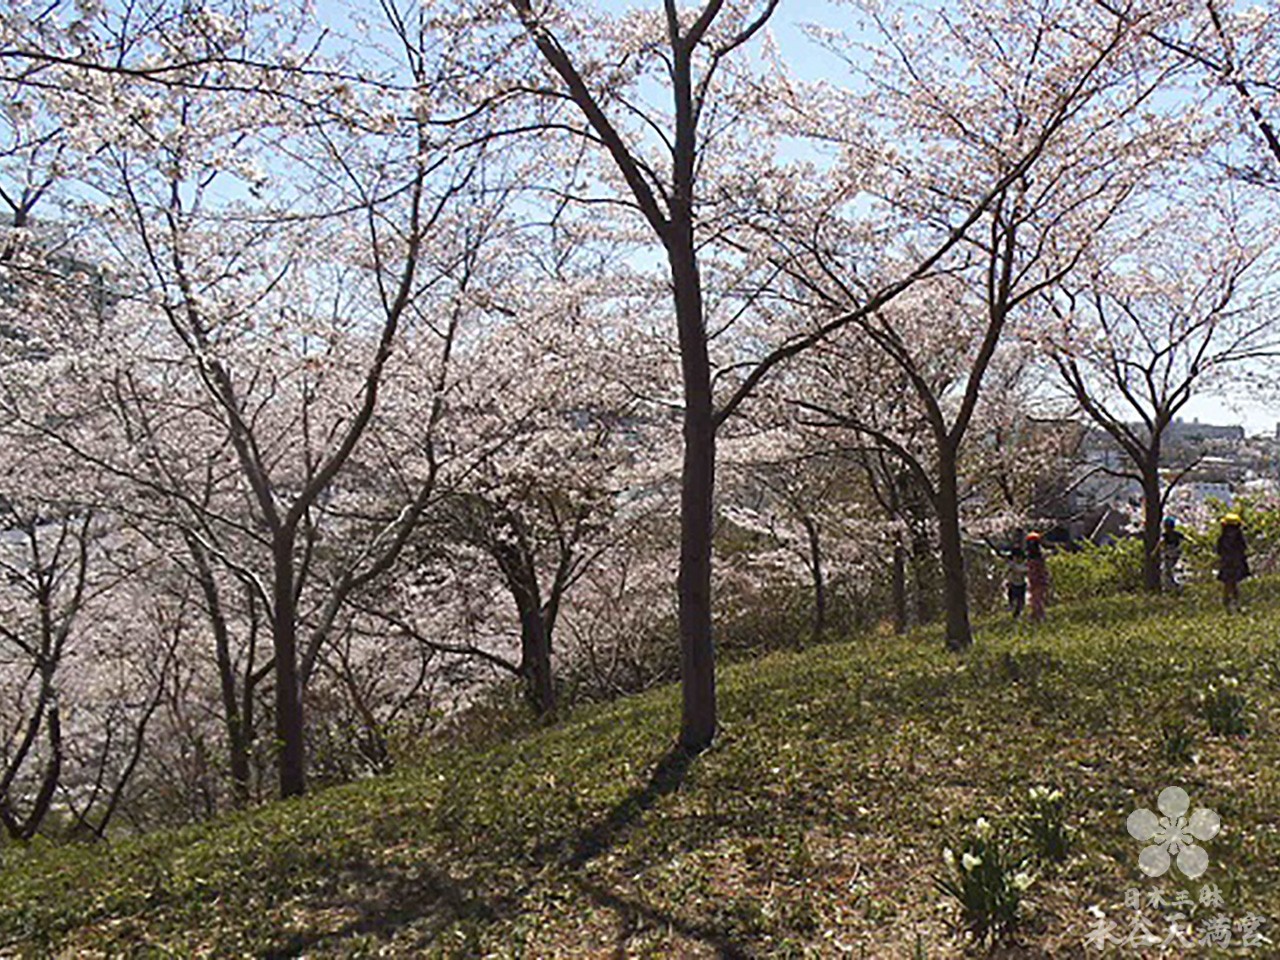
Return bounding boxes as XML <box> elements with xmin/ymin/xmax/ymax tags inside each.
<box><xmin>1000</xmin><ymin>513</ymin><xmax>1249</xmax><ymax>622</ymax></box>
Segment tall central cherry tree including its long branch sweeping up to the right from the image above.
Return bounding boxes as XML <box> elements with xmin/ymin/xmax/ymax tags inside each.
<box><xmin>495</xmin><ymin>0</ymin><xmax>1162</xmax><ymax>750</ymax></box>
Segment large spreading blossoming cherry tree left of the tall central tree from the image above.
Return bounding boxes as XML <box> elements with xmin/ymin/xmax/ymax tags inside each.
<box><xmin>0</xmin><ymin>0</ymin><xmax>519</xmax><ymax>795</ymax></box>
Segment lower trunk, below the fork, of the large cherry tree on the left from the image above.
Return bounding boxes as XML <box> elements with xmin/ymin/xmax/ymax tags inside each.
<box><xmin>271</xmin><ymin>532</ymin><xmax>307</xmax><ymax>797</ymax></box>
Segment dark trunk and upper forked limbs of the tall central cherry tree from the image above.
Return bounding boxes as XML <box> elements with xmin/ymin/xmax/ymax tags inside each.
<box><xmin>496</xmin><ymin>0</ymin><xmax>777</xmax><ymax>750</ymax></box>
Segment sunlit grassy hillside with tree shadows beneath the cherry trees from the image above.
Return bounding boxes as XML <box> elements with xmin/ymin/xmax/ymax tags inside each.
<box><xmin>0</xmin><ymin>581</ymin><xmax>1280</xmax><ymax>957</ymax></box>
